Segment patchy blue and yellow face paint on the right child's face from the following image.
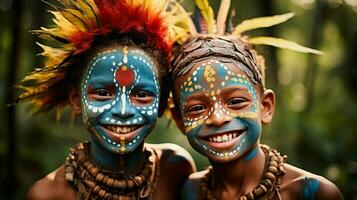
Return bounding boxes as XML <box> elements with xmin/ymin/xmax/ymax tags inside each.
<box><xmin>180</xmin><ymin>60</ymin><xmax>261</xmax><ymax>161</ymax></box>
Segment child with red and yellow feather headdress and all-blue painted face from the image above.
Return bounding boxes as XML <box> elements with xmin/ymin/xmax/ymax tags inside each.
<box><xmin>19</xmin><ymin>0</ymin><xmax>195</xmax><ymax>199</ymax></box>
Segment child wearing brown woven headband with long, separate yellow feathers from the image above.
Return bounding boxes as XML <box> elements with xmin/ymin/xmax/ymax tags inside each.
<box><xmin>172</xmin><ymin>1</ymin><xmax>342</xmax><ymax>200</ymax></box>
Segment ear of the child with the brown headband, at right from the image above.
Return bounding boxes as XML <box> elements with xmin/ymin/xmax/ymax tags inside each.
<box><xmin>261</xmin><ymin>89</ymin><xmax>275</xmax><ymax>124</ymax></box>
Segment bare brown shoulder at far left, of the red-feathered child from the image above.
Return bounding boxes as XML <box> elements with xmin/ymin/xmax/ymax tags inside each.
<box><xmin>26</xmin><ymin>166</ymin><xmax>76</xmax><ymax>200</ymax></box>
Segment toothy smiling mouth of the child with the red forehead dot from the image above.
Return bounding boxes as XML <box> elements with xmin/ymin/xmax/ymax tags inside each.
<box><xmin>102</xmin><ymin>125</ymin><xmax>144</xmax><ymax>143</ymax></box>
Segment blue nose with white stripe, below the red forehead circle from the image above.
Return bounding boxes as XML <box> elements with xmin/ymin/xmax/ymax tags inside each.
<box><xmin>112</xmin><ymin>94</ymin><xmax>135</xmax><ymax>119</ymax></box>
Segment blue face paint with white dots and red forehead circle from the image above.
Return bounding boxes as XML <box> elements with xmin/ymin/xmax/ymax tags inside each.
<box><xmin>81</xmin><ymin>46</ymin><xmax>160</xmax><ymax>154</ymax></box>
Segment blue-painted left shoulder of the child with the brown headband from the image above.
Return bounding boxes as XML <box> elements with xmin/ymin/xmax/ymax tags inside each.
<box><xmin>181</xmin><ymin>170</ymin><xmax>209</xmax><ymax>200</ymax></box>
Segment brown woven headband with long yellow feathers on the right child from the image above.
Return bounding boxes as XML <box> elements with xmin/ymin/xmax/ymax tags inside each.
<box><xmin>172</xmin><ymin>0</ymin><xmax>322</xmax><ymax>86</ymax></box>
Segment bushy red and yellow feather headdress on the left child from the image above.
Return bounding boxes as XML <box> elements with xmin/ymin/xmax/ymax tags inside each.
<box><xmin>17</xmin><ymin>0</ymin><xmax>182</xmax><ymax>111</ymax></box>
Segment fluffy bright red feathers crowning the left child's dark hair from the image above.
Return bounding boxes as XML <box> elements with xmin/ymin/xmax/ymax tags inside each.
<box><xmin>70</xmin><ymin>0</ymin><xmax>172</xmax><ymax>56</ymax></box>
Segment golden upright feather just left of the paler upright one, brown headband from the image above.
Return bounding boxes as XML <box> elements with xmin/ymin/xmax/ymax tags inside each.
<box><xmin>195</xmin><ymin>0</ymin><xmax>216</xmax><ymax>34</ymax></box>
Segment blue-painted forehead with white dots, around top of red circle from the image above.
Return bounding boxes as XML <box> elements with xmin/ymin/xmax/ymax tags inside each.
<box><xmin>87</xmin><ymin>46</ymin><xmax>158</xmax><ymax>77</ymax></box>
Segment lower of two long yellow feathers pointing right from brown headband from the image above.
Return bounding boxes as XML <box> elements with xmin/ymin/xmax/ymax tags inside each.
<box><xmin>248</xmin><ymin>37</ymin><xmax>323</xmax><ymax>55</ymax></box>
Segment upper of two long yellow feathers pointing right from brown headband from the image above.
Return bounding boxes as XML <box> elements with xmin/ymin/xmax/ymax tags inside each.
<box><xmin>232</xmin><ymin>12</ymin><xmax>295</xmax><ymax>35</ymax></box>
